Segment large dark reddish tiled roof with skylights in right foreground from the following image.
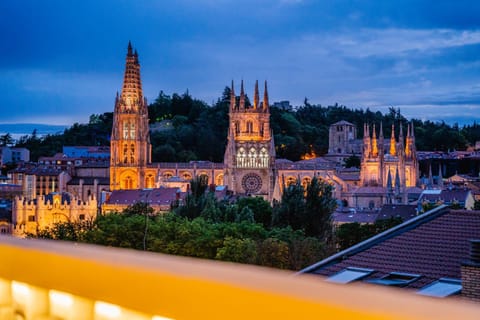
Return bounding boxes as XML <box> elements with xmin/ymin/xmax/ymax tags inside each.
<box><xmin>301</xmin><ymin>206</ymin><xmax>480</xmax><ymax>288</ymax></box>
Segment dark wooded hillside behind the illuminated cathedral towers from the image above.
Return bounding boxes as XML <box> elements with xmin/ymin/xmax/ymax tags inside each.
<box><xmin>9</xmin><ymin>87</ymin><xmax>480</xmax><ymax>161</ymax></box>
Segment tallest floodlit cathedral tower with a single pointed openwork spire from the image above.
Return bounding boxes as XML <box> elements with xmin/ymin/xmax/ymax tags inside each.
<box><xmin>110</xmin><ymin>42</ymin><xmax>155</xmax><ymax>191</ymax></box>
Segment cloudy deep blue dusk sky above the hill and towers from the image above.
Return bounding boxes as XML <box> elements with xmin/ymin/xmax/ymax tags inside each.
<box><xmin>0</xmin><ymin>0</ymin><xmax>480</xmax><ymax>125</ymax></box>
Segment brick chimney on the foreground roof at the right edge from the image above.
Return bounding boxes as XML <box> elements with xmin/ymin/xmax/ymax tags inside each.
<box><xmin>461</xmin><ymin>239</ymin><xmax>480</xmax><ymax>302</ymax></box>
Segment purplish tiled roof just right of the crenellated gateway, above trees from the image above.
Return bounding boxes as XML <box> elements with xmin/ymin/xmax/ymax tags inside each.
<box><xmin>106</xmin><ymin>188</ymin><xmax>179</xmax><ymax>205</ymax></box>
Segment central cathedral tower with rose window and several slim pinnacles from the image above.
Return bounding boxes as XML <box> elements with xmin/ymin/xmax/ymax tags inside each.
<box><xmin>224</xmin><ymin>81</ymin><xmax>275</xmax><ymax>200</ymax></box>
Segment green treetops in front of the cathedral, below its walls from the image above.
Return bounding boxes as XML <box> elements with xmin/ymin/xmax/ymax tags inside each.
<box><xmin>29</xmin><ymin>177</ymin><xmax>335</xmax><ymax>270</ymax></box>
